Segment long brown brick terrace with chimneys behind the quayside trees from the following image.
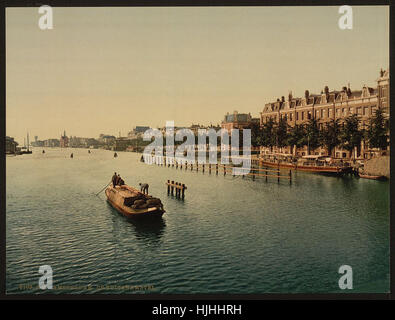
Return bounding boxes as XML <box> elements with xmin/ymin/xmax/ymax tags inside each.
<box><xmin>221</xmin><ymin>70</ymin><xmax>390</xmax><ymax>158</ymax></box>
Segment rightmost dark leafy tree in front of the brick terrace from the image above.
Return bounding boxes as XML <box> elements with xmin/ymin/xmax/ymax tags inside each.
<box><xmin>366</xmin><ymin>109</ymin><xmax>388</xmax><ymax>148</ymax></box>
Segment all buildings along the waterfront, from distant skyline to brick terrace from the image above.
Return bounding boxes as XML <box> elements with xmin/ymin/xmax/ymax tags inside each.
<box><xmin>22</xmin><ymin>70</ymin><xmax>390</xmax><ymax>158</ymax></box>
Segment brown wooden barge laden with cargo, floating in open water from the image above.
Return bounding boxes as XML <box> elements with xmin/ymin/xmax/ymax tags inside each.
<box><xmin>105</xmin><ymin>185</ymin><xmax>165</xmax><ymax>218</ymax></box>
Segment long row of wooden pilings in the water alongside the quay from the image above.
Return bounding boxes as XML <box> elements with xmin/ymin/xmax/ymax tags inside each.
<box><xmin>148</xmin><ymin>157</ymin><xmax>292</xmax><ymax>183</ymax></box>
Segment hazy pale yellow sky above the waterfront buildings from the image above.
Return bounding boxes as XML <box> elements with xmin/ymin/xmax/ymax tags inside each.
<box><xmin>6</xmin><ymin>6</ymin><xmax>389</xmax><ymax>143</ymax></box>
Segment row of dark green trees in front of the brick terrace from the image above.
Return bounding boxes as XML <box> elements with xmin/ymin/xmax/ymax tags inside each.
<box><xmin>251</xmin><ymin>109</ymin><xmax>389</xmax><ymax>155</ymax></box>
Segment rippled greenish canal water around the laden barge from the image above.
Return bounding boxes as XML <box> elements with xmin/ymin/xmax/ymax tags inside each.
<box><xmin>6</xmin><ymin>148</ymin><xmax>389</xmax><ymax>294</ymax></box>
